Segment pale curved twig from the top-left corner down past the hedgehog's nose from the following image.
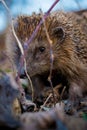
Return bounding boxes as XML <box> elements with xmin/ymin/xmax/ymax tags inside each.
<box><xmin>1</xmin><ymin>0</ymin><xmax>34</xmax><ymax>102</ymax></box>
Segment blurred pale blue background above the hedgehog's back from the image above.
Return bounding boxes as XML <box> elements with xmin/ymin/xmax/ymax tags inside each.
<box><xmin>0</xmin><ymin>0</ymin><xmax>87</xmax><ymax>33</ymax></box>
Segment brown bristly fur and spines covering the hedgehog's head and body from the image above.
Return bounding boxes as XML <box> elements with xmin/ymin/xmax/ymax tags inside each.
<box><xmin>6</xmin><ymin>11</ymin><xmax>87</xmax><ymax>95</ymax></box>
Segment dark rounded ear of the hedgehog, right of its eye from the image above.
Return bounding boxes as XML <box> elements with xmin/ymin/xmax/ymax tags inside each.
<box><xmin>53</xmin><ymin>27</ymin><xmax>65</xmax><ymax>43</ymax></box>
